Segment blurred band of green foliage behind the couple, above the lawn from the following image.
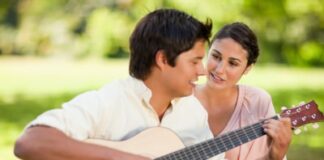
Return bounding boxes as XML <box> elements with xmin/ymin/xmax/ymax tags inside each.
<box><xmin>0</xmin><ymin>0</ymin><xmax>324</xmax><ymax>66</ymax></box>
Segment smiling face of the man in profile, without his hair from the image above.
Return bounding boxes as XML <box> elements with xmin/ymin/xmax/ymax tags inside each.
<box><xmin>162</xmin><ymin>40</ymin><xmax>205</xmax><ymax>97</ymax></box>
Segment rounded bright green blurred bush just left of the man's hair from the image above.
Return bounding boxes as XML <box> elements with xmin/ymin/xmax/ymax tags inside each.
<box><xmin>86</xmin><ymin>8</ymin><xmax>132</xmax><ymax>57</ymax></box>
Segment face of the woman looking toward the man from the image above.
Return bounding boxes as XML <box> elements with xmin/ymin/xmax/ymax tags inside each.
<box><xmin>207</xmin><ymin>38</ymin><xmax>251</xmax><ymax>89</ymax></box>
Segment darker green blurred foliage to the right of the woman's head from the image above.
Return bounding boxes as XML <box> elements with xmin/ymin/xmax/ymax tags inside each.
<box><xmin>242</xmin><ymin>0</ymin><xmax>324</xmax><ymax>66</ymax></box>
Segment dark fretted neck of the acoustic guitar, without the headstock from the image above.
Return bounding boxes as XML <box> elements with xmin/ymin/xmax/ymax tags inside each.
<box><xmin>156</xmin><ymin>116</ymin><xmax>278</xmax><ymax>160</ymax></box>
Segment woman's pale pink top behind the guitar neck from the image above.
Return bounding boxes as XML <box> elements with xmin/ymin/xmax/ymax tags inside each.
<box><xmin>220</xmin><ymin>85</ymin><xmax>275</xmax><ymax>160</ymax></box>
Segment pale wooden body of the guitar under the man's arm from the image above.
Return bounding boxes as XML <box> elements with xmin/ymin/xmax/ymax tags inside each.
<box><xmin>86</xmin><ymin>127</ymin><xmax>185</xmax><ymax>158</ymax></box>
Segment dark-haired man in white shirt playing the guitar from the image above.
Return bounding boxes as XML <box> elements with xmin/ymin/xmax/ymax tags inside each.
<box><xmin>14</xmin><ymin>9</ymin><xmax>218</xmax><ymax>160</ymax></box>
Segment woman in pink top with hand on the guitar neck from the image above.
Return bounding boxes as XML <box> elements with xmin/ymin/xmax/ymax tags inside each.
<box><xmin>195</xmin><ymin>23</ymin><xmax>291</xmax><ymax>160</ymax></box>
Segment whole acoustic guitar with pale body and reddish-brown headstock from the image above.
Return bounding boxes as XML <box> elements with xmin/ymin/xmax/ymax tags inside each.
<box><xmin>86</xmin><ymin>101</ymin><xmax>324</xmax><ymax>160</ymax></box>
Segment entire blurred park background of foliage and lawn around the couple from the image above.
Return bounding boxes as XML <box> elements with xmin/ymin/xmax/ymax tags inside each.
<box><xmin>0</xmin><ymin>0</ymin><xmax>324</xmax><ymax>160</ymax></box>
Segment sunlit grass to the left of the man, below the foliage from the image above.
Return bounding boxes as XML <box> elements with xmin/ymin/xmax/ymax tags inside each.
<box><xmin>0</xmin><ymin>58</ymin><xmax>128</xmax><ymax>160</ymax></box>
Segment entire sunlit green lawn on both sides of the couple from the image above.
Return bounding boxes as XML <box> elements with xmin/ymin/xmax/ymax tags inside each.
<box><xmin>0</xmin><ymin>58</ymin><xmax>324</xmax><ymax>160</ymax></box>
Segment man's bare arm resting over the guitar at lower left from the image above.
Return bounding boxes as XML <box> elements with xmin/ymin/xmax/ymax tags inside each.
<box><xmin>14</xmin><ymin>126</ymin><xmax>148</xmax><ymax>160</ymax></box>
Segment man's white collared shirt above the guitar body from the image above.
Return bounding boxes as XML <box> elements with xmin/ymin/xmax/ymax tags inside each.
<box><xmin>28</xmin><ymin>77</ymin><xmax>213</xmax><ymax>146</ymax></box>
